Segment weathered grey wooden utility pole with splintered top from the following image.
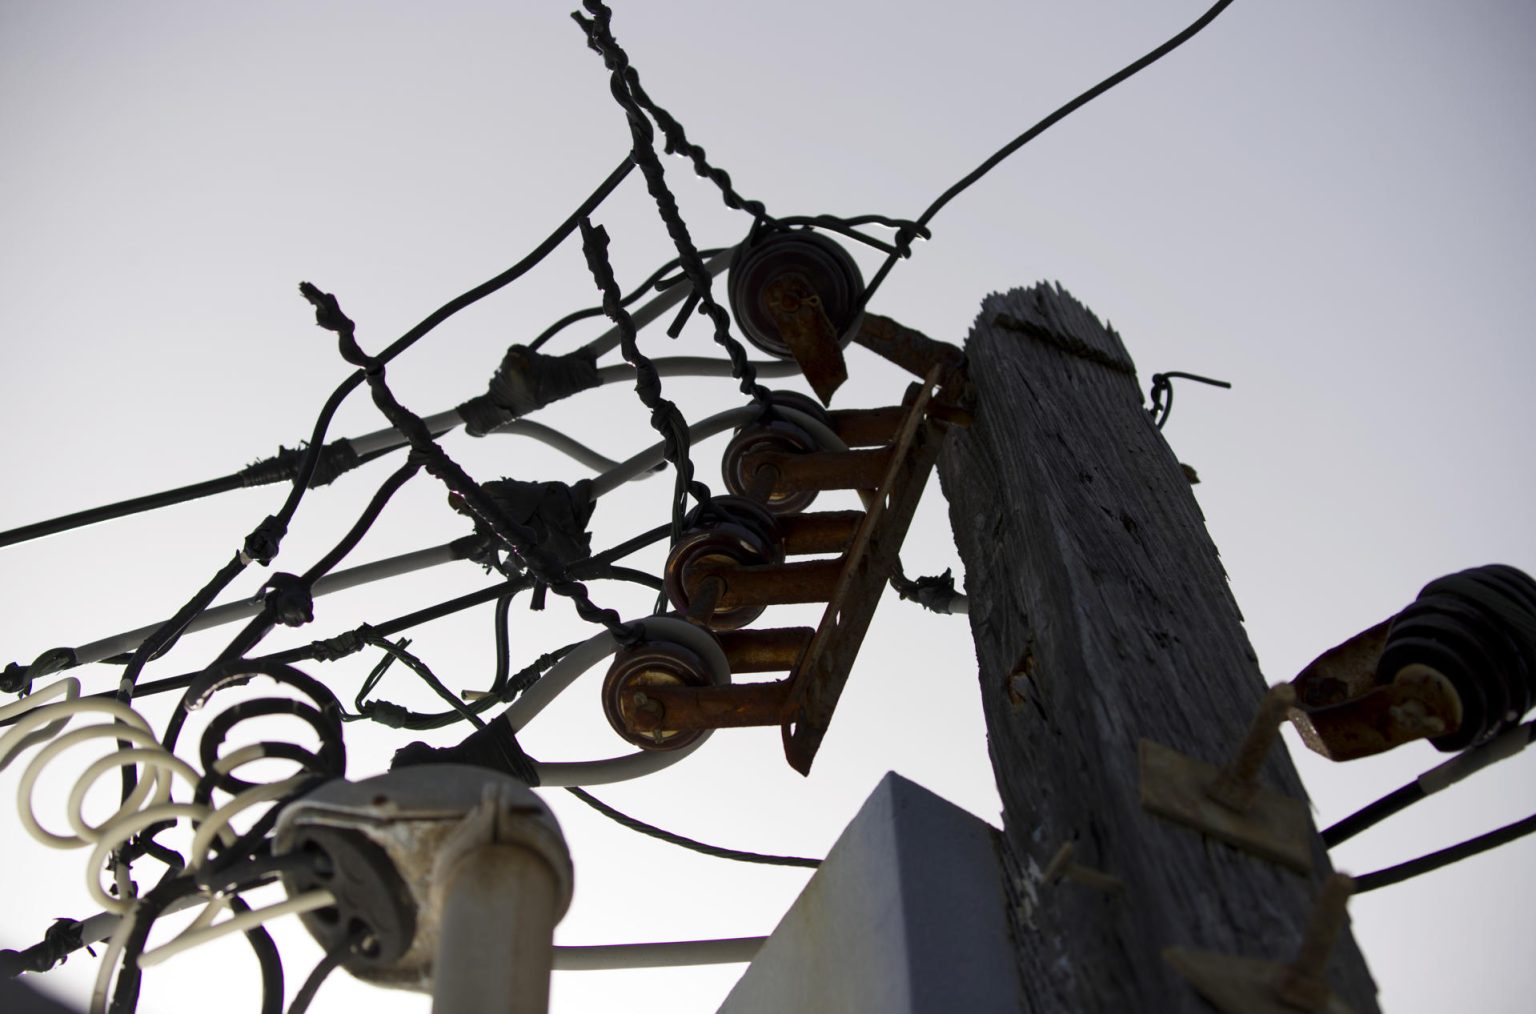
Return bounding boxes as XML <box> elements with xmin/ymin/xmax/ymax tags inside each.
<box><xmin>938</xmin><ymin>284</ymin><xmax>1378</xmax><ymax>1014</ymax></box>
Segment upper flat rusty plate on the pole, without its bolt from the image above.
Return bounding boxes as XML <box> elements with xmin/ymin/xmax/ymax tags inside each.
<box><xmin>1141</xmin><ymin>739</ymin><xmax>1312</xmax><ymax>873</ymax></box>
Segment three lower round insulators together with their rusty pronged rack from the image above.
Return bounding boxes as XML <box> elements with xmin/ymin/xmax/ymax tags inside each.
<box><xmin>604</xmin><ymin>369</ymin><xmax>963</xmax><ymax>773</ymax></box>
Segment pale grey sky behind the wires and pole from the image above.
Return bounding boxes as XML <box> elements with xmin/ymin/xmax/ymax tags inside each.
<box><xmin>0</xmin><ymin>0</ymin><xmax>1536</xmax><ymax>1014</ymax></box>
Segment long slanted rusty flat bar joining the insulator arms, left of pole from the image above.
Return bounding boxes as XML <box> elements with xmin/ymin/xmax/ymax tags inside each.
<box><xmin>783</xmin><ymin>366</ymin><xmax>963</xmax><ymax>774</ymax></box>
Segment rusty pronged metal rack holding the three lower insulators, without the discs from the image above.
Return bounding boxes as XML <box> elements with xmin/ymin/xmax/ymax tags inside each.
<box><xmin>604</xmin><ymin>366</ymin><xmax>968</xmax><ymax>774</ymax></box>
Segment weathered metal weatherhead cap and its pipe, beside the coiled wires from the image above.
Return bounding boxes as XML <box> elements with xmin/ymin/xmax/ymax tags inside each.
<box><xmin>273</xmin><ymin>764</ymin><xmax>573</xmax><ymax>1014</ymax></box>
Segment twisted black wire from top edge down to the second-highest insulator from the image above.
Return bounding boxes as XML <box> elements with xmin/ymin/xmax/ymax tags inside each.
<box><xmin>571</xmin><ymin>0</ymin><xmax>770</xmax><ymax>406</ymax></box>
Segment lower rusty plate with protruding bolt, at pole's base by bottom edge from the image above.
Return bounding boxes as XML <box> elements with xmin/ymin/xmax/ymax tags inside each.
<box><xmin>1163</xmin><ymin>873</ymin><xmax>1355</xmax><ymax>1014</ymax></box>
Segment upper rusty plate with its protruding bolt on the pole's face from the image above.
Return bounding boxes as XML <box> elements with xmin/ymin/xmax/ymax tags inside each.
<box><xmin>1141</xmin><ymin>684</ymin><xmax>1313</xmax><ymax>873</ymax></box>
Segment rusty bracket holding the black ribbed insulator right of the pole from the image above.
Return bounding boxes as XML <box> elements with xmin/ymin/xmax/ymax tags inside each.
<box><xmin>1290</xmin><ymin>619</ymin><xmax>1462</xmax><ymax>761</ymax></box>
